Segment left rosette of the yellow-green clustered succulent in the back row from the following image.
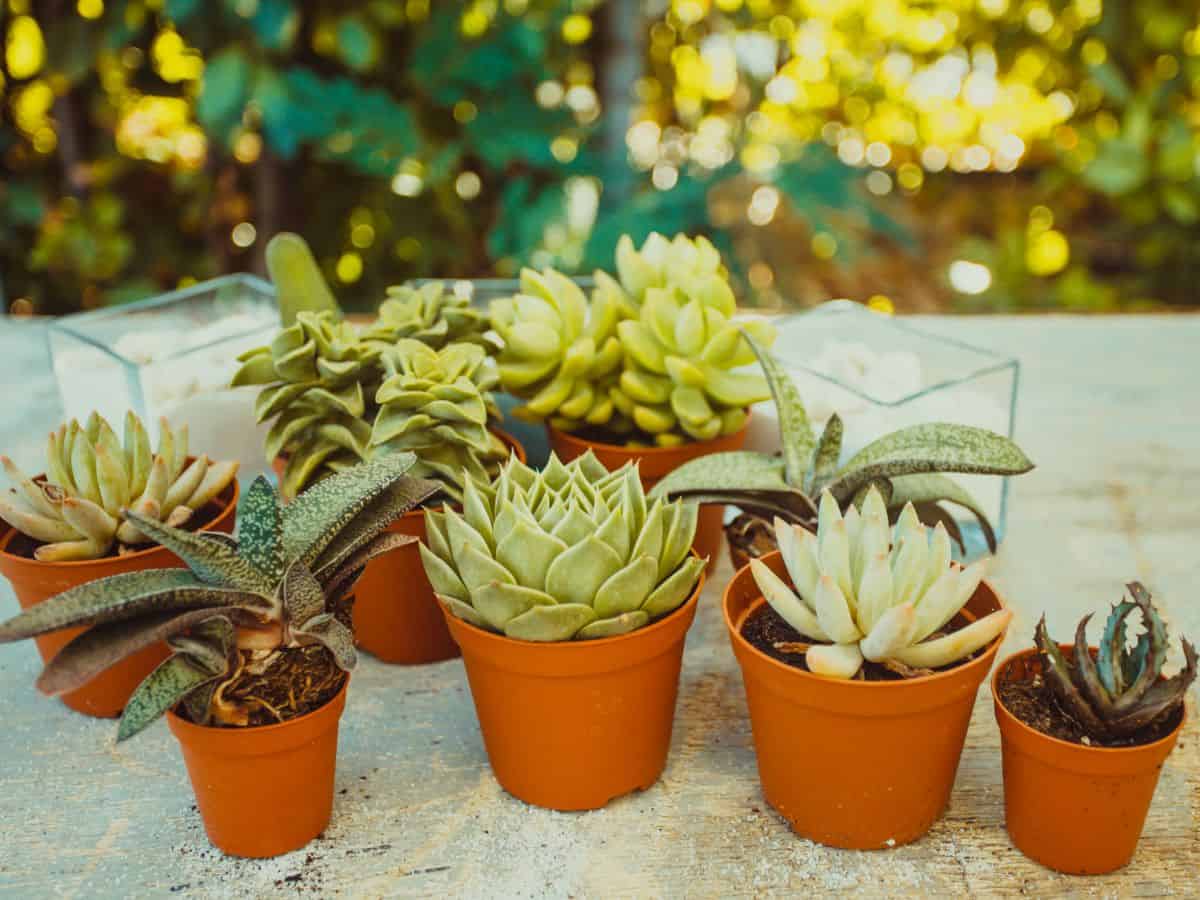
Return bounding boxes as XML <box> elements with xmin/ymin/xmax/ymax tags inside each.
<box><xmin>491</xmin><ymin>269</ymin><xmax>631</xmax><ymax>433</ymax></box>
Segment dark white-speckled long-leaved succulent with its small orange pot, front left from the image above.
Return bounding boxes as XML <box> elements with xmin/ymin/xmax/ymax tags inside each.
<box><xmin>0</xmin><ymin>454</ymin><xmax>437</xmax><ymax>857</ymax></box>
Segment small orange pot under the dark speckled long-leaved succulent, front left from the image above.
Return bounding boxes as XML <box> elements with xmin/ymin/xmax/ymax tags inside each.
<box><xmin>167</xmin><ymin>679</ymin><xmax>349</xmax><ymax>857</ymax></box>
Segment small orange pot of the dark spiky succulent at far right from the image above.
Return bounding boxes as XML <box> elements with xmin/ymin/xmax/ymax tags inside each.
<box><xmin>991</xmin><ymin>644</ymin><xmax>1183</xmax><ymax>875</ymax></box>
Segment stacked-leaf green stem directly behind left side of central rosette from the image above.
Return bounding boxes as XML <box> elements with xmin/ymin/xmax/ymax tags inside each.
<box><xmin>371</xmin><ymin>340</ymin><xmax>509</xmax><ymax>500</ymax></box>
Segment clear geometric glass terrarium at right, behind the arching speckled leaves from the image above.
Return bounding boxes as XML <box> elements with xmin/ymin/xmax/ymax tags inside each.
<box><xmin>749</xmin><ymin>300</ymin><xmax>1020</xmax><ymax>557</ymax></box>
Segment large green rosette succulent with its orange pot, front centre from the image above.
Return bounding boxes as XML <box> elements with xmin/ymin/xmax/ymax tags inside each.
<box><xmin>420</xmin><ymin>454</ymin><xmax>704</xmax><ymax>810</ymax></box>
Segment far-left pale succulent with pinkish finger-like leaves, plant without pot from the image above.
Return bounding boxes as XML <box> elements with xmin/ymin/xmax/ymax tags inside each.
<box><xmin>0</xmin><ymin>412</ymin><xmax>238</xmax><ymax>563</ymax></box>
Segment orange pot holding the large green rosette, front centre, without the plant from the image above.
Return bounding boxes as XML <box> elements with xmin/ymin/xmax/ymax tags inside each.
<box><xmin>444</xmin><ymin>576</ymin><xmax>704</xmax><ymax>810</ymax></box>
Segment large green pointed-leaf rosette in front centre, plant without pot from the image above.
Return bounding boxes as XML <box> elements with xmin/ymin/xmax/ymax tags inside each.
<box><xmin>421</xmin><ymin>452</ymin><xmax>704</xmax><ymax>641</ymax></box>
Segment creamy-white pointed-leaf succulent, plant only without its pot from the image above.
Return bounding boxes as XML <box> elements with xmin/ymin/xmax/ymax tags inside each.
<box><xmin>750</xmin><ymin>487</ymin><xmax>1013</xmax><ymax>678</ymax></box>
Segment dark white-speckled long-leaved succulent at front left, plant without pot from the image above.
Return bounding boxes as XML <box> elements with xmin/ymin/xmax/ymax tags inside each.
<box><xmin>0</xmin><ymin>454</ymin><xmax>437</xmax><ymax>740</ymax></box>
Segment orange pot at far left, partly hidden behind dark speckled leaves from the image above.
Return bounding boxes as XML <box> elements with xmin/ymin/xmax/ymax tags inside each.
<box><xmin>0</xmin><ymin>481</ymin><xmax>238</xmax><ymax>719</ymax></box>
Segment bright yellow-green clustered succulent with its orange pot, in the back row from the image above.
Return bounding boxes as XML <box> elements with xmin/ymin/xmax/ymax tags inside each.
<box><xmin>490</xmin><ymin>234</ymin><xmax>775</xmax><ymax>571</ymax></box>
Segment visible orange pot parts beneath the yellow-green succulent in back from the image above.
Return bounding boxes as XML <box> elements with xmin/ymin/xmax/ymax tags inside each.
<box><xmin>546</xmin><ymin>422</ymin><xmax>749</xmax><ymax>572</ymax></box>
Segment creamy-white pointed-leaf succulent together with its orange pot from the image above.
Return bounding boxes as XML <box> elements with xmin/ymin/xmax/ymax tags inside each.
<box><xmin>725</xmin><ymin>487</ymin><xmax>1012</xmax><ymax>850</ymax></box>
